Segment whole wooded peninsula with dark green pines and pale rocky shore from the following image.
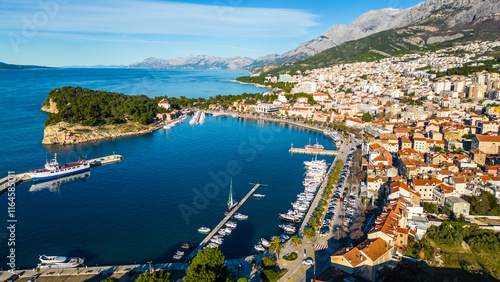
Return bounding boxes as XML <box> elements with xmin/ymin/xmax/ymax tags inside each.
<box><xmin>41</xmin><ymin>87</ymin><xmax>166</xmax><ymax>145</ymax></box>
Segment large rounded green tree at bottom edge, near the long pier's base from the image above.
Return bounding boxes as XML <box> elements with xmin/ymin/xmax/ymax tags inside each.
<box><xmin>184</xmin><ymin>248</ymin><xmax>231</xmax><ymax>282</ymax></box>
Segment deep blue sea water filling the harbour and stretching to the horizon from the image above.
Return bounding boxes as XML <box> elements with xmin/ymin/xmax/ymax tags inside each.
<box><xmin>0</xmin><ymin>68</ymin><xmax>335</xmax><ymax>270</ymax></box>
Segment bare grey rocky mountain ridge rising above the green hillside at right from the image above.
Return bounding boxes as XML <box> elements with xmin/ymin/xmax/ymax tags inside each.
<box><xmin>248</xmin><ymin>0</ymin><xmax>500</xmax><ymax>69</ymax></box>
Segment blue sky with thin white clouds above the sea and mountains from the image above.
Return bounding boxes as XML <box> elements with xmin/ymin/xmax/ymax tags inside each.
<box><xmin>0</xmin><ymin>0</ymin><xmax>421</xmax><ymax>66</ymax></box>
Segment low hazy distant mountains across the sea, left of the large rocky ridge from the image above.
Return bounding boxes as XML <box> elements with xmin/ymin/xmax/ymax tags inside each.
<box><xmin>128</xmin><ymin>55</ymin><xmax>254</xmax><ymax>70</ymax></box>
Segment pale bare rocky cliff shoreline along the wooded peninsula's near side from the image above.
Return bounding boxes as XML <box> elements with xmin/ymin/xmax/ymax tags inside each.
<box><xmin>42</xmin><ymin>122</ymin><xmax>164</xmax><ymax>145</ymax></box>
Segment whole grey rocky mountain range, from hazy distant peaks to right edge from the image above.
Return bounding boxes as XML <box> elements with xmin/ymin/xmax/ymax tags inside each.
<box><xmin>129</xmin><ymin>0</ymin><xmax>500</xmax><ymax>70</ymax></box>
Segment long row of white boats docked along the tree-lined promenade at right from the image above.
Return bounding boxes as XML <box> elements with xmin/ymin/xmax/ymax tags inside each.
<box><xmin>279</xmin><ymin>160</ymin><xmax>327</xmax><ymax>227</ymax></box>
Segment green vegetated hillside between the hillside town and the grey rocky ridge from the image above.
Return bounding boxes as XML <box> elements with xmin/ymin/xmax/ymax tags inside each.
<box><xmin>254</xmin><ymin>13</ymin><xmax>500</xmax><ymax>74</ymax></box>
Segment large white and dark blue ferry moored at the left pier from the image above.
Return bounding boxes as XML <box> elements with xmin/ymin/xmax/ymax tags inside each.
<box><xmin>28</xmin><ymin>154</ymin><xmax>90</xmax><ymax>181</ymax></box>
